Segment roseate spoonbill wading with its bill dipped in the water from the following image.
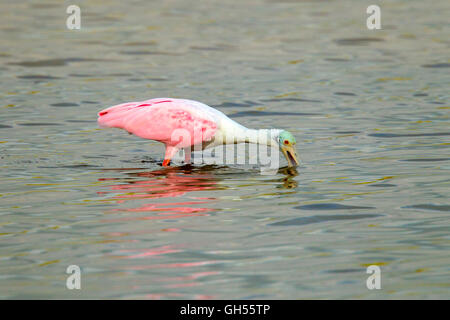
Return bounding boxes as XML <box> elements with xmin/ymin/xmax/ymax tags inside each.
<box><xmin>98</xmin><ymin>98</ymin><xmax>298</xmax><ymax>167</ymax></box>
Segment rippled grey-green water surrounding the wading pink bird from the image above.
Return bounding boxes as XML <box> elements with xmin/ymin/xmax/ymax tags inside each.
<box><xmin>0</xmin><ymin>0</ymin><xmax>450</xmax><ymax>299</ymax></box>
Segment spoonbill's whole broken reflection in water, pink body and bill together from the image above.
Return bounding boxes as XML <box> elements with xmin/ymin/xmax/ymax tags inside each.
<box><xmin>99</xmin><ymin>166</ymin><xmax>297</xmax><ymax>299</ymax></box>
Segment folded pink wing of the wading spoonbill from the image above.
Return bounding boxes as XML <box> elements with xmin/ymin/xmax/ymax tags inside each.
<box><xmin>98</xmin><ymin>98</ymin><xmax>217</xmax><ymax>147</ymax></box>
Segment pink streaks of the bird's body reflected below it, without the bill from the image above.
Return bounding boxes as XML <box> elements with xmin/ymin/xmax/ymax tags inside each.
<box><xmin>98</xmin><ymin>168</ymin><xmax>223</xmax><ymax>299</ymax></box>
